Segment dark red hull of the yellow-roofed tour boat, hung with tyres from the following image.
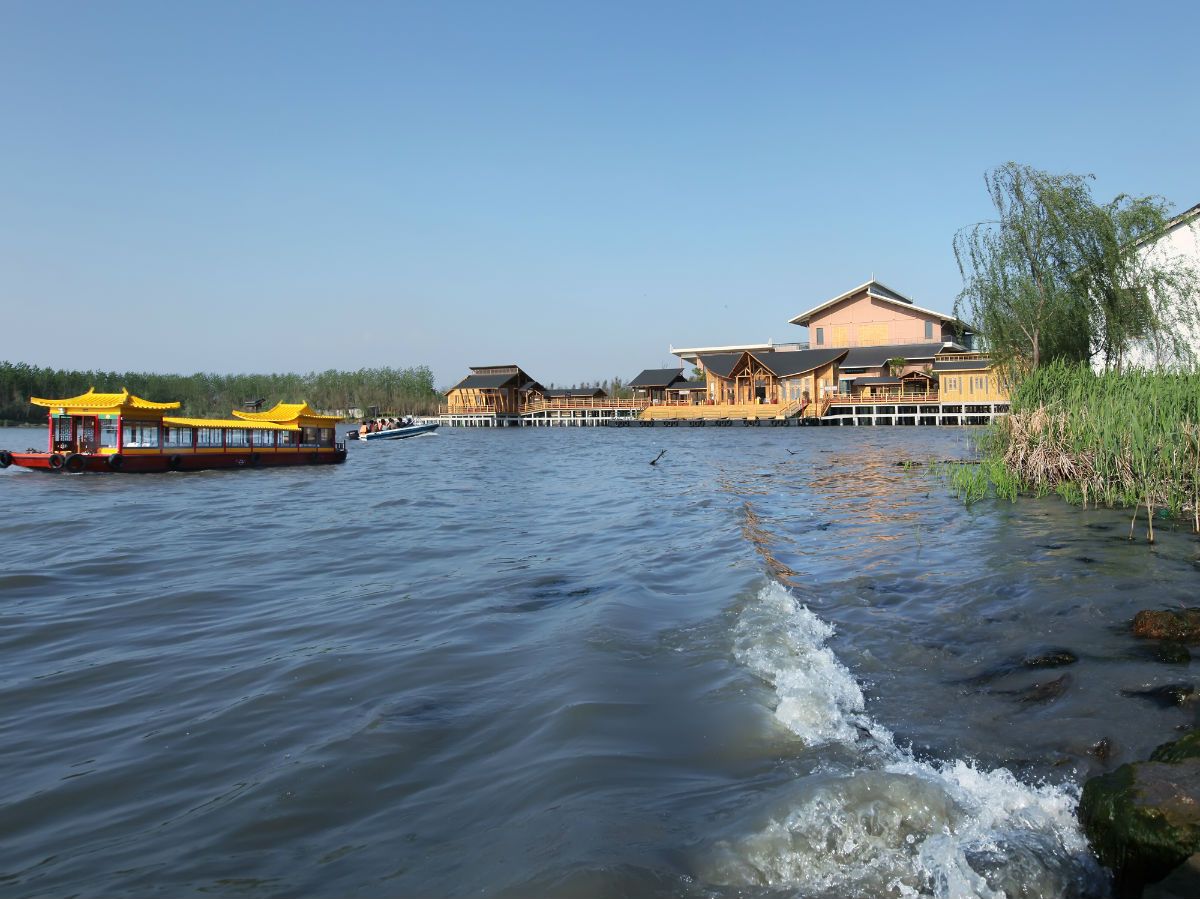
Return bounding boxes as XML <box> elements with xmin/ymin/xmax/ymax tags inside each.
<box><xmin>2</xmin><ymin>446</ymin><xmax>346</xmax><ymax>474</ymax></box>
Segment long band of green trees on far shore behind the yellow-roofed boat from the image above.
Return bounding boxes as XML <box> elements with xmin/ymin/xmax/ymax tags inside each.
<box><xmin>0</xmin><ymin>361</ymin><xmax>443</xmax><ymax>421</ymax></box>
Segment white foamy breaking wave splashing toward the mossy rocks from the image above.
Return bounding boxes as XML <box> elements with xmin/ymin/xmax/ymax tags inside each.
<box><xmin>702</xmin><ymin>582</ymin><xmax>1109</xmax><ymax>899</ymax></box>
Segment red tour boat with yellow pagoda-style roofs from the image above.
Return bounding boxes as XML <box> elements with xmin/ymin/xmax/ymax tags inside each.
<box><xmin>0</xmin><ymin>388</ymin><xmax>346</xmax><ymax>473</ymax></box>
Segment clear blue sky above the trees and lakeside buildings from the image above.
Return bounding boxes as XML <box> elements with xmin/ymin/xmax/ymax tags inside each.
<box><xmin>0</xmin><ymin>0</ymin><xmax>1200</xmax><ymax>385</ymax></box>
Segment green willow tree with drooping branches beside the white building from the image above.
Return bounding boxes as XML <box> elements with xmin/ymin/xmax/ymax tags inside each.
<box><xmin>954</xmin><ymin>162</ymin><xmax>1198</xmax><ymax>368</ymax></box>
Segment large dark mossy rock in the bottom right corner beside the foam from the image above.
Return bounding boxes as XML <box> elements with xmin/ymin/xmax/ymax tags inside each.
<box><xmin>1079</xmin><ymin>759</ymin><xmax>1200</xmax><ymax>897</ymax></box>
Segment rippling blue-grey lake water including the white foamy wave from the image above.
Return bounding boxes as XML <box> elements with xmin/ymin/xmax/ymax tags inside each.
<box><xmin>0</xmin><ymin>428</ymin><xmax>1200</xmax><ymax>899</ymax></box>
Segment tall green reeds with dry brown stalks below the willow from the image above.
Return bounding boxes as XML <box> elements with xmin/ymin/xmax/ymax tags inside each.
<box><xmin>982</xmin><ymin>364</ymin><xmax>1200</xmax><ymax>541</ymax></box>
